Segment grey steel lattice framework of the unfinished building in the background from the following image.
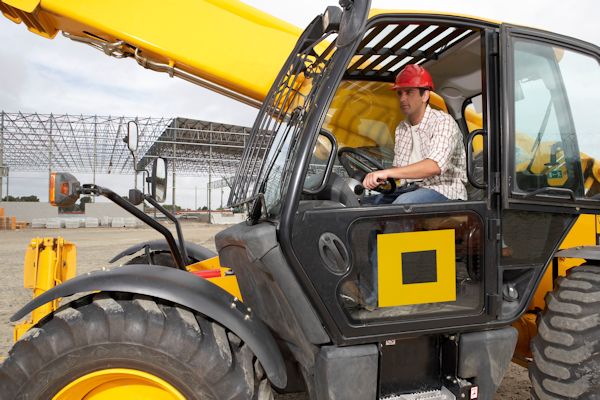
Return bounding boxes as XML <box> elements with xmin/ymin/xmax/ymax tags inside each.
<box><xmin>0</xmin><ymin>111</ymin><xmax>250</xmax><ymax>204</ymax></box>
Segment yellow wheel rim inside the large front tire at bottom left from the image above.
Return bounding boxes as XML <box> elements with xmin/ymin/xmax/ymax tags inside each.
<box><xmin>53</xmin><ymin>368</ymin><xmax>185</xmax><ymax>400</ymax></box>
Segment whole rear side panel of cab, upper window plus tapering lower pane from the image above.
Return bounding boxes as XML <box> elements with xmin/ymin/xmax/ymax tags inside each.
<box><xmin>499</xmin><ymin>25</ymin><xmax>600</xmax><ymax>320</ymax></box>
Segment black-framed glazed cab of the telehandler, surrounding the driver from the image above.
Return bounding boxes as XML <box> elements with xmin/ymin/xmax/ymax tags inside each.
<box><xmin>224</xmin><ymin>2</ymin><xmax>600</xmax><ymax>398</ymax></box>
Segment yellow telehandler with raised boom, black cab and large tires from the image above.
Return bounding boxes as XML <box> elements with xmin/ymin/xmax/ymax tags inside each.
<box><xmin>0</xmin><ymin>0</ymin><xmax>600</xmax><ymax>400</ymax></box>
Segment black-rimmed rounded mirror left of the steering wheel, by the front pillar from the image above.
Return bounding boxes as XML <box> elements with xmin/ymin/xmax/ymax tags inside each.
<box><xmin>302</xmin><ymin>129</ymin><xmax>337</xmax><ymax>194</ymax></box>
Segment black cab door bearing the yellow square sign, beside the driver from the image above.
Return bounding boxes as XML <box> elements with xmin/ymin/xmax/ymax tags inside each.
<box><xmin>279</xmin><ymin>15</ymin><xmax>500</xmax><ymax>344</ymax></box>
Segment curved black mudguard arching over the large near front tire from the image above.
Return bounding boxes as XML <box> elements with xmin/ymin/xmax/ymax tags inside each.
<box><xmin>10</xmin><ymin>265</ymin><xmax>287</xmax><ymax>388</ymax></box>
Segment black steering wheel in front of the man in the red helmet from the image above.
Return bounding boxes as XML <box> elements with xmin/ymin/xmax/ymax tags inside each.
<box><xmin>338</xmin><ymin>147</ymin><xmax>396</xmax><ymax>194</ymax></box>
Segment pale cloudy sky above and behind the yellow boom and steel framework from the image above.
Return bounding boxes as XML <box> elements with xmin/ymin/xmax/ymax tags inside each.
<box><xmin>0</xmin><ymin>0</ymin><xmax>600</xmax><ymax>208</ymax></box>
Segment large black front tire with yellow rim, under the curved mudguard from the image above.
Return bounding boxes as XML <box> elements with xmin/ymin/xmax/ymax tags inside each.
<box><xmin>0</xmin><ymin>293</ymin><xmax>272</xmax><ymax>400</ymax></box>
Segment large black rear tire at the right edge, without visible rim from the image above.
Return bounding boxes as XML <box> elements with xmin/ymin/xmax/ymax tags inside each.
<box><xmin>529</xmin><ymin>265</ymin><xmax>600</xmax><ymax>400</ymax></box>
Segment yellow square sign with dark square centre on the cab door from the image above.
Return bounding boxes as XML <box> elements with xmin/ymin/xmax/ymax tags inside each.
<box><xmin>377</xmin><ymin>229</ymin><xmax>456</xmax><ymax>307</ymax></box>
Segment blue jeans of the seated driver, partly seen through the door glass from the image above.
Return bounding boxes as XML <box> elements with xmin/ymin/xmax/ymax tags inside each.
<box><xmin>359</xmin><ymin>188</ymin><xmax>448</xmax><ymax>308</ymax></box>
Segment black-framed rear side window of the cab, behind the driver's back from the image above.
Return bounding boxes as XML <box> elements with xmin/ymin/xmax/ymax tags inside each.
<box><xmin>501</xmin><ymin>25</ymin><xmax>600</xmax><ymax>214</ymax></box>
